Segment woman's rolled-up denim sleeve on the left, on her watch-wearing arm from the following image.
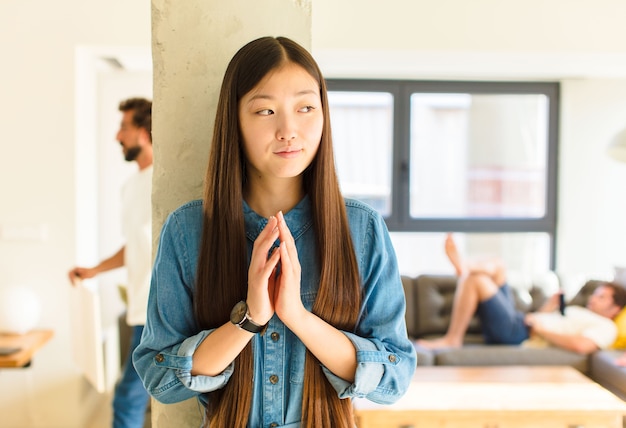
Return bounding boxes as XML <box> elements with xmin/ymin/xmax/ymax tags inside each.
<box><xmin>133</xmin><ymin>204</ymin><xmax>233</xmax><ymax>403</ymax></box>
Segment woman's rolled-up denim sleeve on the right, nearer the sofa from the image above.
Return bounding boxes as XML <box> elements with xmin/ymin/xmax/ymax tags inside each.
<box><xmin>324</xmin><ymin>205</ymin><xmax>417</xmax><ymax>404</ymax></box>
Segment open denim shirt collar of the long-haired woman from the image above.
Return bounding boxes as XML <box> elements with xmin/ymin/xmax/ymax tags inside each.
<box><xmin>243</xmin><ymin>195</ymin><xmax>313</xmax><ymax>242</ymax></box>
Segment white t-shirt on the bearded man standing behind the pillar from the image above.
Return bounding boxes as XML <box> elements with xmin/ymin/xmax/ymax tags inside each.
<box><xmin>122</xmin><ymin>165</ymin><xmax>152</xmax><ymax>326</ymax></box>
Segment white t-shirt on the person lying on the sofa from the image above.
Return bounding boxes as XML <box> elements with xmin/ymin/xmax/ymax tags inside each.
<box><xmin>533</xmin><ymin>306</ymin><xmax>617</xmax><ymax>349</ymax></box>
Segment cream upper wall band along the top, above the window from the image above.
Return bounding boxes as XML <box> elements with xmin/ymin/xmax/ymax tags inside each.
<box><xmin>313</xmin><ymin>0</ymin><xmax>626</xmax><ymax>53</ymax></box>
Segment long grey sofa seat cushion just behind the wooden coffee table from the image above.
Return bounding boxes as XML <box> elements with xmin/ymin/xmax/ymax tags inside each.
<box><xmin>426</xmin><ymin>345</ymin><xmax>589</xmax><ymax>373</ymax></box>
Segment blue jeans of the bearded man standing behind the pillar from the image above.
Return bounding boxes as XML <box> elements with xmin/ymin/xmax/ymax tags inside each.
<box><xmin>113</xmin><ymin>325</ymin><xmax>150</xmax><ymax>428</ymax></box>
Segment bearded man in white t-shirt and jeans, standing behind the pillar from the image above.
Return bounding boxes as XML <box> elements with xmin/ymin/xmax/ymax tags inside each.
<box><xmin>69</xmin><ymin>98</ymin><xmax>152</xmax><ymax>428</ymax></box>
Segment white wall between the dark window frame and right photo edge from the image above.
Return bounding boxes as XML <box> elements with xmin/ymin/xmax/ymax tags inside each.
<box><xmin>557</xmin><ymin>79</ymin><xmax>626</xmax><ymax>276</ymax></box>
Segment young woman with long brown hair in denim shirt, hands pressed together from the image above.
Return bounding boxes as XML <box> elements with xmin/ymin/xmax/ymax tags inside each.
<box><xmin>134</xmin><ymin>37</ymin><xmax>416</xmax><ymax>428</ymax></box>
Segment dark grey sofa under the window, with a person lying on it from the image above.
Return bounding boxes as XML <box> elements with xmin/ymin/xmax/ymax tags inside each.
<box><xmin>402</xmin><ymin>275</ymin><xmax>626</xmax><ymax>400</ymax></box>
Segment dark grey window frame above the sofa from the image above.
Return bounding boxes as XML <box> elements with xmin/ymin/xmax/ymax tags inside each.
<box><xmin>326</xmin><ymin>79</ymin><xmax>560</xmax><ymax>268</ymax></box>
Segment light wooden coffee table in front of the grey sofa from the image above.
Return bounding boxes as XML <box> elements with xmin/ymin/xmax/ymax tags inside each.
<box><xmin>354</xmin><ymin>366</ymin><xmax>626</xmax><ymax>428</ymax></box>
